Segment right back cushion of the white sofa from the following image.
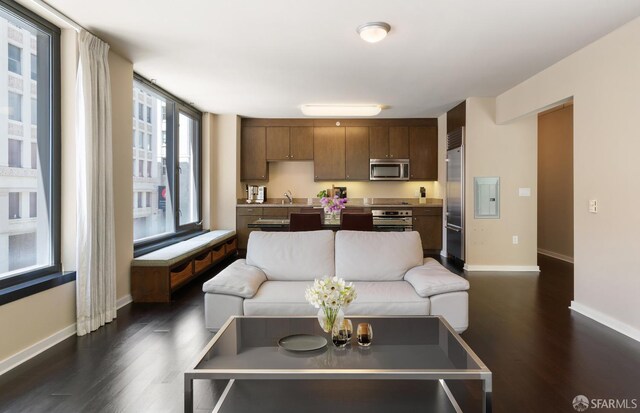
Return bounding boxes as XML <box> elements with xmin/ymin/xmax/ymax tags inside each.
<box><xmin>336</xmin><ymin>231</ymin><xmax>423</xmax><ymax>281</ymax></box>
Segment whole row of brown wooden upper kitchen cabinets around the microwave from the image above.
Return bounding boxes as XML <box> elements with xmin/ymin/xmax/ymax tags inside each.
<box><xmin>240</xmin><ymin>118</ymin><xmax>438</xmax><ymax>181</ymax></box>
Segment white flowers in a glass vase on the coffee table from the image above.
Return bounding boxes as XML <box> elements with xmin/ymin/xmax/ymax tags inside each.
<box><xmin>304</xmin><ymin>277</ymin><xmax>357</xmax><ymax>333</ymax></box>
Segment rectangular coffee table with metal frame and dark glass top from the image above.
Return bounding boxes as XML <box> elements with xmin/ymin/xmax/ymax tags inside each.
<box><xmin>184</xmin><ymin>316</ymin><xmax>491</xmax><ymax>413</ymax></box>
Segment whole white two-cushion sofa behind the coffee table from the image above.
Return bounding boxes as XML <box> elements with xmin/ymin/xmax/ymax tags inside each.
<box><xmin>202</xmin><ymin>231</ymin><xmax>469</xmax><ymax>333</ymax></box>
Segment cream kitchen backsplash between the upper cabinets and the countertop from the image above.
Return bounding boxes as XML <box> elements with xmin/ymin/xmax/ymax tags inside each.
<box><xmin>238</xmin><ymin>161</ymin><xmax>443</xmax><ymax>198</ymax></box>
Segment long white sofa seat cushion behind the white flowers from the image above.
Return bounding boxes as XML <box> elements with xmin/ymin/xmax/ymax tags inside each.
<box><xmin>244</xmin><ymin>281</ymin><xmax>430</xmax><ymax>316</ymax></box>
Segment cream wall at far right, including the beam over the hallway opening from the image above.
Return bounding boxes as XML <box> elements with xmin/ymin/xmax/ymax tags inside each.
<box><xmin>496</xmin><ymin>18</ymin><xmax>640</xmax><ymax>340</ymax></box>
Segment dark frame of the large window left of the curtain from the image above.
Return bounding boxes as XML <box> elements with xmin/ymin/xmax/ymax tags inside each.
<box><xmin>0</xmin><ymin>0</ymin><xmax>65</xmax><ymax>305</ymax></box>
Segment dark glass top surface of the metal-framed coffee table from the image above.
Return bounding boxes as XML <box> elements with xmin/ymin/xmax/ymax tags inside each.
<box><xmin>192</xmin><ymin>316</ymin><xmax>491</xmax><ymax>379</ymax></box>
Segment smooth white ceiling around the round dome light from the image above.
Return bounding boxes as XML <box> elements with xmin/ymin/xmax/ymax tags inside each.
<box><xmin>42</xmin><ymin>0</ymin><xmax>640</xmax><ymax>117</ymax></box>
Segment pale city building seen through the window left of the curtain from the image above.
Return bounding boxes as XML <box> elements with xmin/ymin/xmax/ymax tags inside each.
<box><xmin>0</xmin><ymin>15</ymin><xmax>51</xmax><ymax>278</ymax></box>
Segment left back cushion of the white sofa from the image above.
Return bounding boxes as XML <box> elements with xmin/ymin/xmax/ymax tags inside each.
<box><xmin>246</xmin><ymin>230</ymin><xmax>335</xmax><ymax>281</ymax></box>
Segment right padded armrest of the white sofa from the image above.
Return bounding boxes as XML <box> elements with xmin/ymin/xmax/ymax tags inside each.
<box><xmin>404</xmin><ymin>260</ymin><xmax>469</xmax><ymax>297</ymax></box>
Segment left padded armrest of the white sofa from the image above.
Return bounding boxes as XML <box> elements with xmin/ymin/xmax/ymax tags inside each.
<box><xmin>202</xmin><ymin>260</ymin><xmax>267</xmax><ymax>298</ymax></box>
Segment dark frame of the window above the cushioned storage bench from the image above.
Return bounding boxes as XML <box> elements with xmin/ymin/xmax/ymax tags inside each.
<box><xmin>132</xmin><ymin>72</ymin><xmax>202</xmax><ymax>256</ymax></box>
